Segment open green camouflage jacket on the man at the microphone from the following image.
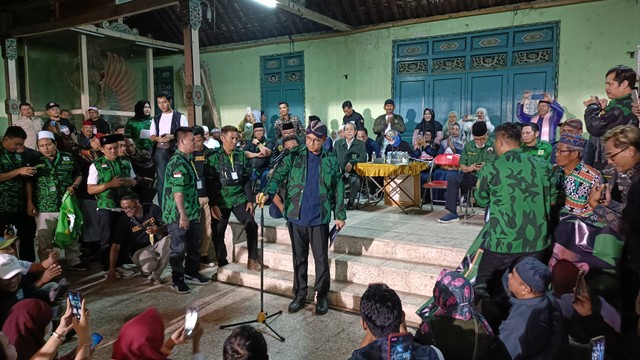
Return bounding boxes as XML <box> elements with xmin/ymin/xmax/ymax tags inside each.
<box><xmin>264</xmin><ymin>145</ymin><xmax>347</xmax><ymax>224</ymax></box>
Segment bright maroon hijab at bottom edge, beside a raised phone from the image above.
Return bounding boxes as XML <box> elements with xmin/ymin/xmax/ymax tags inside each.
<box><xmin>111</xmin><ymin>307</ymin><xmax>167</xmax><ymax>360</ymax></box>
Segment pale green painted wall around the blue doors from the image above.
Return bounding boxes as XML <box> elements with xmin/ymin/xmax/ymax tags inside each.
<box><xmin>155</xmin><ymin>0</ymin><xmax>640</xmax><ymax>129</ymax></box>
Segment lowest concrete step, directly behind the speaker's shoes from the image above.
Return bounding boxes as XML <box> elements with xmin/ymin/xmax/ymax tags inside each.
<box><xmin>217</xmin><ymin>263</ymin><xmax>429</xmax><ymax>327</ymax></box>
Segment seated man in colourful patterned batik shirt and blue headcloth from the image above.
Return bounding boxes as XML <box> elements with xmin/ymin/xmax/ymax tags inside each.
<box><xmin>556</xmin><ymin>135</ymin><xmax>602</xmax><ymax>220</ymax></box>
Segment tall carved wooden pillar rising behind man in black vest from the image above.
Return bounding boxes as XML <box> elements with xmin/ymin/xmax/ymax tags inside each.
<box><xmin>180</xmin><ymin>0</ymin><xmax>204</xmax><ymax>126</ymax></box>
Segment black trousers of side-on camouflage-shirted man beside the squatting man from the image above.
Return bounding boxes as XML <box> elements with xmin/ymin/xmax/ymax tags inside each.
<box><xmin>167</xmin><ymin>221</ymin><xmax>202</xmax><ymax>280</ymax></box>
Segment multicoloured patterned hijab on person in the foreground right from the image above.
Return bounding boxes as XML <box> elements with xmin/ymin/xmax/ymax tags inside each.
<box><xmin>420</xmin><ymin>270</ymin><xmax>493</xmax><ymax>335</ymax></box>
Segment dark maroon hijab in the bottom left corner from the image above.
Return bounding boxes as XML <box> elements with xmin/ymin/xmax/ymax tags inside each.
<box><xmin>2</xmin><ymin>299</ymin><xmax>53</xmax><ymax>360</ymax></box>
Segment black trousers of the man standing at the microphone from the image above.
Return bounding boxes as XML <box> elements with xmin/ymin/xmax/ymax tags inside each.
<box><xmin>287</xmin><ymin>222</ymin><xmax>331</xmax><ymax>297</ymax></box>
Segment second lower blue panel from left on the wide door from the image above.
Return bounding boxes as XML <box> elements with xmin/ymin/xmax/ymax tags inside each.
<box><xmin>426</xmin><ymin>74</ymin><xmax>466</xmax><ymax>124</ymax></box>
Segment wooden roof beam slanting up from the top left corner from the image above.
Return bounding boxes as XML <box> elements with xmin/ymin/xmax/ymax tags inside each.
<box><xmin>6</xmin><ymin>0</ymin><xmax>178</xmax><ymax>37</ymax></box>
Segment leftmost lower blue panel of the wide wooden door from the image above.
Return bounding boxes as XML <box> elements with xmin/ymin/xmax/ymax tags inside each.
<box><xmin>396</xmin><ymin>79</ymin><xmax>427</xmax><ymax>140</ymax></box>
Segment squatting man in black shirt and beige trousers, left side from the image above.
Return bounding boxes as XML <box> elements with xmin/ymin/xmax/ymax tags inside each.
<box><xmin>107</xmin><ymin>193</ymin><xmax>171</xmax><ymax>285</ymax></box>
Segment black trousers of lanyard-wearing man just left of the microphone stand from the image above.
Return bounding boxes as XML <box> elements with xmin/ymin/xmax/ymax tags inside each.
<box><xmin>211</xmin><ymin>203</ymin><xmax>258</xmax><ymax>265</ymax></box>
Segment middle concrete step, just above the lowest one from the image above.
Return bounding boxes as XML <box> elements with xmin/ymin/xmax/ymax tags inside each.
<box><xmin>234</xmin><ymin>242</ymin><xmax>442</xmax><ymax>296</ymax></box>
